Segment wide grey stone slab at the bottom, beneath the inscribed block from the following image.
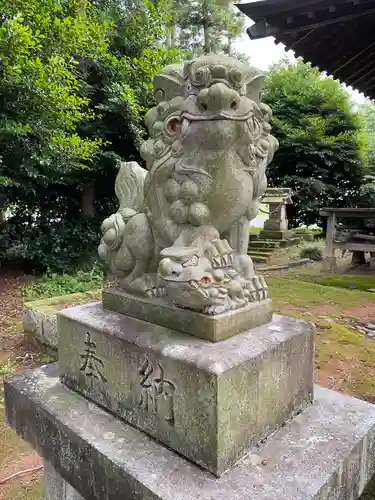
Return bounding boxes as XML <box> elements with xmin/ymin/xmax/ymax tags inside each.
<box><xmin>5</xmin><ymin>366</ymin><xmax>375</xmax><ymax>500</ymax></box>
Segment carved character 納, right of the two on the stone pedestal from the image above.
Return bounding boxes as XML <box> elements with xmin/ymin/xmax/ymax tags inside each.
<box><xmin>138</xmin><ymin>358</ymin><xmax>176</xmax><ymax>425</ymax></box>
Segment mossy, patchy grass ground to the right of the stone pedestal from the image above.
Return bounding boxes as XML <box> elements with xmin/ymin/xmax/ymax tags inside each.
<box><xmin>268</xmin><ymin>272</ymin><xmax>375</xmax><ymax>500</ymax></box>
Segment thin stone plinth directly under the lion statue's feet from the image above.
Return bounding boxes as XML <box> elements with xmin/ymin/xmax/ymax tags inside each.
<box><xmin>102</xmin><ymin>288</ymin><xmax>272</xmax><ymax>342</ymax></box>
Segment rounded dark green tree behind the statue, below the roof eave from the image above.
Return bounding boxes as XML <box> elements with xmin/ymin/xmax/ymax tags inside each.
<box><xmin>264</xmin><ymin>61</ymin><xmax>364</xmax><ymax>227</ymax></box>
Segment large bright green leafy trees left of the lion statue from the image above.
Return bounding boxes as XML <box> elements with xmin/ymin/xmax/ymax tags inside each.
<box><xmin>0</xmin><ymin>0</ymin><xmax>178</xmax><ymax>270</ymax></box>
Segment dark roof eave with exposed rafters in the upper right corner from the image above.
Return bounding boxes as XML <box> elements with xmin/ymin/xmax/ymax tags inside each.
<box><xmin>237</xmin><ymin>0</ymin><xmax>375</xmax><ymax>99</ymax></box>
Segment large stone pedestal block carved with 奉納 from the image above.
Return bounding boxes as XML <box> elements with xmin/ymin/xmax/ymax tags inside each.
<box><xmin>59</xmin><ymin>304</ymin><xmax>314</xmax><ymax>475</ymax></box>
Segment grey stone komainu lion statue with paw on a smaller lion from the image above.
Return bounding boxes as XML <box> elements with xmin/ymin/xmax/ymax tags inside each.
<box><xmin>99</xmin><ymin>55</ymin><xmax>278</xmax><ymax>314</ymax></box>
